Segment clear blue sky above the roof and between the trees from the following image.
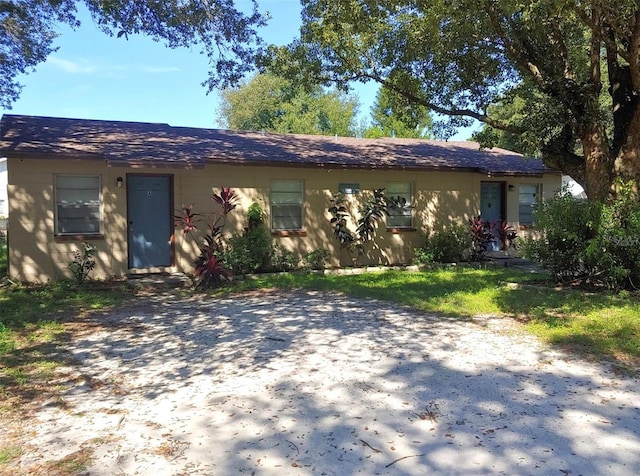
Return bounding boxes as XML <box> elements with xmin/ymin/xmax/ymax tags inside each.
<box><xmin>2</xmin><ymin>0</ymin><xmax>476</xmax><ymax>138</ymax></box>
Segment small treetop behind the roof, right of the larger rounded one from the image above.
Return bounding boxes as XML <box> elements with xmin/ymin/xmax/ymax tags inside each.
<box><xmin>362</xmin><ymin>86</ymin><xmax>432</xmax><ymax>139</ymax></box>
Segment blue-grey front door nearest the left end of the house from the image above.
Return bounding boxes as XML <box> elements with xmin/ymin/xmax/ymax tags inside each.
<box><xmin>127</xmin><ymin>175</ymin><xmax>173</xmax><ymax>268</ymax></box>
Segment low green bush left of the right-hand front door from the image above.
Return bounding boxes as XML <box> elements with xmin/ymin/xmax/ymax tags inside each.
<box><xmin>414</xmin><ymin>223</ymin><xmax>471</xmax><ymax>264</ymax></box>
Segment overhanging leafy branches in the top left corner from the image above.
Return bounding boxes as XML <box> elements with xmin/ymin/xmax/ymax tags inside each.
<box><xmin>0</xmin><ymin>0</ymin><xmax>266</xmax><ymax>108</ymax></box>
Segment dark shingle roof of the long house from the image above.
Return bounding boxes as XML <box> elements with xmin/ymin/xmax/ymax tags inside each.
<box><xmin>0</xmin><ymin>115</ymin><xmax>553</xmax><ymax>175</ymax></box>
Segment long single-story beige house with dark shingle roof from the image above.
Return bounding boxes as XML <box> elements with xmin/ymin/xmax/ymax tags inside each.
<box><xmin>0</xmin><ymin>115</ymin><xmax>561</xmax><ymax>281</ymax></box>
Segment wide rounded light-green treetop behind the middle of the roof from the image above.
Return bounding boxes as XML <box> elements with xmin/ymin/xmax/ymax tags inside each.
<box><xmin>219</xmin><ymin>73</ymin><xmax>358</xmax><ymax>137</ymax></box>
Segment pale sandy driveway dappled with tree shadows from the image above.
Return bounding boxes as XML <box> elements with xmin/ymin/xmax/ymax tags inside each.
<box><xmin>11</xmin><ymin>291</ymin><xmax>640</xmax><ymax>476</ymax></box>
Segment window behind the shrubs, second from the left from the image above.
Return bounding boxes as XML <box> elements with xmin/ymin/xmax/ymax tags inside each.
<box><xmin>269</xmin><ymin>180</ymin><xmax>304</xmax><ymax>230</ymax></box>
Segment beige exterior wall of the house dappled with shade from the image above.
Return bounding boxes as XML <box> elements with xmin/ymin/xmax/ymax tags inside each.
<box><xmin>8</xmin><ymin>158</ymin><xmax>560</xmax><ymax>281</ymax></box>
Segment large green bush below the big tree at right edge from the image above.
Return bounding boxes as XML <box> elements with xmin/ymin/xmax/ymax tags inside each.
<box><xmin>522</xmin><ymin>184</ymin><xmax>640</xmax><ymax>289</ymax></box>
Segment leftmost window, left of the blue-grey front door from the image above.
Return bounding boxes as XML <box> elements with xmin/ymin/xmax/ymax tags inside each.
<box><xmin>55</xmin><ymin>175</ymin><xmax>102</xmax><ymax>235</ymax></box>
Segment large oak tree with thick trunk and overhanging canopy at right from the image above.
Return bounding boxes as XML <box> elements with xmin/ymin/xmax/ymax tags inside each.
<box><xmin>271</xmin><ymin>0</ymin><xmax>640</xmax><ymax>199</ymax></box>
